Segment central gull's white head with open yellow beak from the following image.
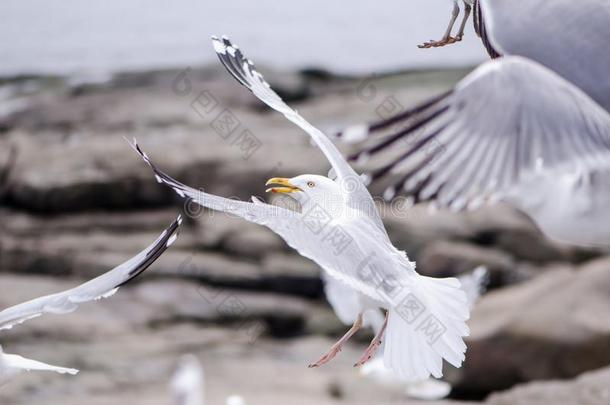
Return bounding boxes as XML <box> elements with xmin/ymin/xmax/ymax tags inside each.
<box><xmin>266</xmin><ymin>174</ymin><xmax>343</xmax><ymax>212</ymax></box>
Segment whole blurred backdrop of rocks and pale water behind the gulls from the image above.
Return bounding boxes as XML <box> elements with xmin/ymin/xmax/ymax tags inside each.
<box><xmin>0</xmin><ymin>0</ymin><xmax>610</xmax><ymax>405</ymax></box>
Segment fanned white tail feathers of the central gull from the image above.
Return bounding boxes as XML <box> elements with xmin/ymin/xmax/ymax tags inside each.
<box><xmin>384</xmin><ymin>276</ymin><xmax>469</xmax><ymax>380</ymax></box>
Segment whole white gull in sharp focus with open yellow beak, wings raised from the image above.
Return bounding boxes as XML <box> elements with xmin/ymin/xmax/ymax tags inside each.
<box><xmin>132</xmin><ymin>38</ymin><xmax>469</xmax><ymax>379</ymax></box>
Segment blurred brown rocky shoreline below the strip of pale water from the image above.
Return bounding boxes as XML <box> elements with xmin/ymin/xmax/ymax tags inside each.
<box><xmin>0</xmin><ymin>67</ymin><xmax>610</xmax><ymax>405</ymax></box>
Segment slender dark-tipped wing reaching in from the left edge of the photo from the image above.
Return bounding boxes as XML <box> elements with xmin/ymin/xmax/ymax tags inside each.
<box><xmin>0</xmin><ymin>217</ymin><xmax>182</xmax><ymax>330</ymax></box>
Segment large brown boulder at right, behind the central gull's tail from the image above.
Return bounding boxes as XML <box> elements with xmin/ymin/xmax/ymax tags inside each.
<box><xmin>451</xmin><ymin>259</ymin><xmax>610</xmax><ymax>392</ymax></box>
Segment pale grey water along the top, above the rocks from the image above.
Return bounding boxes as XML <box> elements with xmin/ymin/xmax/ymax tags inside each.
<box><xmin>0</xmin><ymin>0</ymin><xmax>486</xmax><ymax>76</ymax></box>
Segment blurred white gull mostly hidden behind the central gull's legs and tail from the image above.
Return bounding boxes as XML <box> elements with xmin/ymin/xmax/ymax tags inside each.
<box><xmin>323</xmin><ymin>266</ymin><xmax>489</xmax><ymax>400</ymax></box>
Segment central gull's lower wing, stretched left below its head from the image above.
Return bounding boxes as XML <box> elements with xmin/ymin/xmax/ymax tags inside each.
<box><xmin>130</xmin><ymin>139</ymin><xmax>390</xmax><ymax>300</ymax></box>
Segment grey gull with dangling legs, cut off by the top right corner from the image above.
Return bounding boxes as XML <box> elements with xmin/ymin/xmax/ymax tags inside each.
<box><xmin>427</xmin><ymin>0</ymin><xmax>610</xmax><ymax>111</ymax></box>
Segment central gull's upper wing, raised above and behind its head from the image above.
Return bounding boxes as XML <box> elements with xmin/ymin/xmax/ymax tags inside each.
<box><xmin>212</xmin><ymin>37</ymin><xmax>385</xmax><ymax>234</ymax></box>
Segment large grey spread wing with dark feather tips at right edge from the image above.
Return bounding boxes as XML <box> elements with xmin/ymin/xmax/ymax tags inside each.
<box><xmin>342</xmin><ymin>56</ymin><xmax>610</xmax><ymax>210</ymax></box>
